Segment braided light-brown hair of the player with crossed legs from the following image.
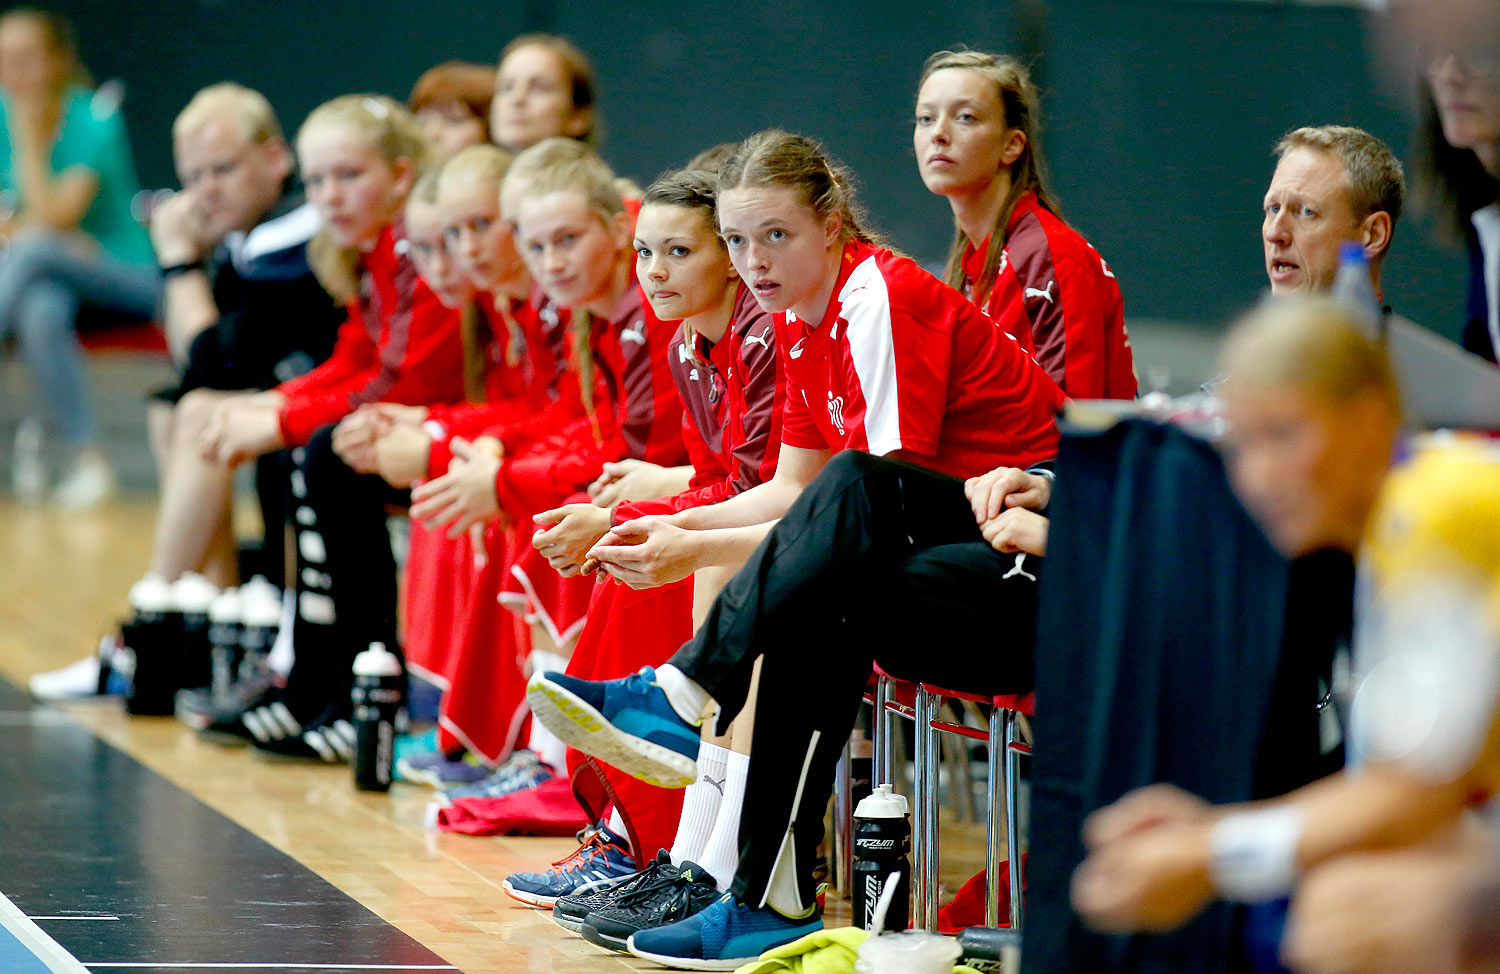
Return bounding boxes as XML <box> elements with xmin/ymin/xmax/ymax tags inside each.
<box><xmin>719</xmin><ymin>129</ymin><xmax>885</xmax><ymax>246</ymax></box>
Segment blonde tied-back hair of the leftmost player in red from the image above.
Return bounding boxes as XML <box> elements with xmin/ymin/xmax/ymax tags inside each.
<box><xmin>297</xmin><ymin>95</ymin><xmax>431</xmax><ymax>303</ymax></box>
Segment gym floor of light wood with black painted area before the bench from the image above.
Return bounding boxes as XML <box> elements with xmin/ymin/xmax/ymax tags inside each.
<box><xmin>0</xmin><ymin>497</ymin><xmax>984</xmax><ymax>974</ymax></box>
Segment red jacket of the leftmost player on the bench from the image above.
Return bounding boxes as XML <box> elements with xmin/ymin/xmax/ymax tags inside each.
<box><xmin>276</xmin><ymin>225</ymin><xmax>464</xmax><ymax>446</ymax></box>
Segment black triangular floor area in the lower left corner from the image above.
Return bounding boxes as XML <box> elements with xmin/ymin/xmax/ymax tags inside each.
<box><xmin>0</xmin><ymin>681</ymin><xmax>446</xmax><ymax>974</ymax></box>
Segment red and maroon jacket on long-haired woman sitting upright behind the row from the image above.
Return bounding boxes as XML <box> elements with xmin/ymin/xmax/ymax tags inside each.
<box><xmin>963</xmin><ymin>192</ymin><xmax>1136</xmax><ymax>399</ymax></box>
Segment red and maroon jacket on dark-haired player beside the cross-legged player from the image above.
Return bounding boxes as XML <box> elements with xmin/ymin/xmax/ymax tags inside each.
<box><xmin>614</xmin><ymin>284</ymin><xmax>786</xmax><ymax>524</ymax></box>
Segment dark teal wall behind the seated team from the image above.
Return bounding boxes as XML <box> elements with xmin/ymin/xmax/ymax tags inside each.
<box><xmin>49</xmin><ymin>0</ymin><xmax>1463</xmax><ymax>335</ymax></box>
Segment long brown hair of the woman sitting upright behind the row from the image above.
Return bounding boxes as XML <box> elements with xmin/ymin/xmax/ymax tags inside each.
<box><xmin>917</xmin><ymin>51</ymin><xmax>1062</xmax><ymax>306</ymax></box>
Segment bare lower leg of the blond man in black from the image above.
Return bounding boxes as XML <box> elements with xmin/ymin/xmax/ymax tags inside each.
<box><xmin>152</xmin><ymin>389</ymin><xmax>237</xmax><ymax>579</ymax></box>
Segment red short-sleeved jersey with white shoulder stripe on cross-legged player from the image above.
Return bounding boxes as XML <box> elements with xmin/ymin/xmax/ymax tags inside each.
<box><xmin>776</xmin><ymin>242</ymin><xmax>1064</xmax><ymax>477</ymax></box>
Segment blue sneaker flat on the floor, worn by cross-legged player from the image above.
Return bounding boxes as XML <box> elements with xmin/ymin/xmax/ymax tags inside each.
<box><xmin>626</xmin><ymin>893</ymin><xmax>824</xmax><ymax>971</ymax></box>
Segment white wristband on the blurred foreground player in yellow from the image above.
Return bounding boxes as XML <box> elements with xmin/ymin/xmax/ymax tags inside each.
<box><xmin>1209</xmin><ymin>807</ymin><xmax>1302</xmax><ymax>903</ymax></box>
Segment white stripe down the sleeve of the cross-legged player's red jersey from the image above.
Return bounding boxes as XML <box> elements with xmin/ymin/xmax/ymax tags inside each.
<box><xmin>839</xmin><ymin>257</ymin><xmax>902</xmax><ymax>456</ymax></box>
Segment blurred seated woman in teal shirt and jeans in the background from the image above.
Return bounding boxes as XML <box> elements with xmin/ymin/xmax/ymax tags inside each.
<box><xmin>0</xmin><ymin>9</ymin><xmax>161</xmax><ymax>509</ymax></box>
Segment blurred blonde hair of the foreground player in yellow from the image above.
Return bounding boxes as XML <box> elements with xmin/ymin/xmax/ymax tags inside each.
<box><xmin>1223</xmin><ymin>294</ymin><xmax>1401</xmax><ymax>416</ymax></box>
